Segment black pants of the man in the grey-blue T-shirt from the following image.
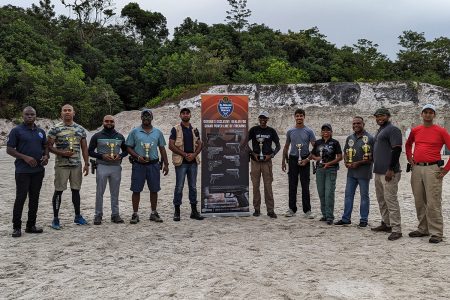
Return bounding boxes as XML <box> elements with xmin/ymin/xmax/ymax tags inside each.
<box><xmin>288</xmin><ymin>156</ymin><xmax>311</xmax><ymax>213</ymax></box>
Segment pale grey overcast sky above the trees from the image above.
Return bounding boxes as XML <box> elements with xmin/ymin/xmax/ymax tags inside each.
<box><xmin>0</xmin><ymin>0</ymin><xmax>450</xmax><ymax>59</ymax></box>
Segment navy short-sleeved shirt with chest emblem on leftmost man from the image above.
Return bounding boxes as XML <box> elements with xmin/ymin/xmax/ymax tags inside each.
<box><xmin>6</xmin><ymin>124</ymin><xmax>47</xmax><ymax>173</ymax></box>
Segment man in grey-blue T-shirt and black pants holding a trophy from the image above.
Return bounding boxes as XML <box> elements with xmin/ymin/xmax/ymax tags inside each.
<box><xmin>281</xmin><ymin>108</ymin><xmax>316</xmax><ymax>219</ymax></box>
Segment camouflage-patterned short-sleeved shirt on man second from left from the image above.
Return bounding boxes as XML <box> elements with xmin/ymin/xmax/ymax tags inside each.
<box><xmin>48</xmin><ymin>122</ymin><xmax>86</xmax><ymax>167</ymax></box>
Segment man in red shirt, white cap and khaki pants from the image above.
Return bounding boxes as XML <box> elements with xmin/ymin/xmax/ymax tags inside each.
<box><xmin>406</xmin><ymin>104</ymin><xmax>450</xmax><ymax>244</ymax></box>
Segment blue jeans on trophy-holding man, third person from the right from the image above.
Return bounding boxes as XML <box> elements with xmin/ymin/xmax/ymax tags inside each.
<box><xmin>342</xmin><ymin>176</ymin><xmax>370</xmax><ymax>222</ymax></box>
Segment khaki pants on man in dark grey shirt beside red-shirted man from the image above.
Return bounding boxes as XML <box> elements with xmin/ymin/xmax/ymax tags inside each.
<box><xmin>375</xmin><ymin>173</ymin><xmax>402</xmax><ymax>233</ymax></box>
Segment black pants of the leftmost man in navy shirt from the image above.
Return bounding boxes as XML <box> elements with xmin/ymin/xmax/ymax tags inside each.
<box><xmin>13</xmin><ymin>171</ymin><xmax>45</xmax><ymax>228</ymax></box>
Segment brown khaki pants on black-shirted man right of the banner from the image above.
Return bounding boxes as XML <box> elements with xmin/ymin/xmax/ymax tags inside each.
<box><xmin>250</xmin><ymin>160</ymin><xmax>275</xmax><ymax>212</ymax></box>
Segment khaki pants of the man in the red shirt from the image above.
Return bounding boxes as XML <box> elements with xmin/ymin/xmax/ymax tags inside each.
<box><xmin>411</xmin><ymin>165</ymin><xmax>444</xmax><ymax>237</ymax></box>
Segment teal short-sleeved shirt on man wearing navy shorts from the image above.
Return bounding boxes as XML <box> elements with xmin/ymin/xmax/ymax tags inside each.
<box><xmin>125</xmin><ymin>126</ymin><xmax>166</xmax><ymax>160</ymax></box>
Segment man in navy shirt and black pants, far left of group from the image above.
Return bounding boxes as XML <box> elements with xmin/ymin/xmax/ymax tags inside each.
<box><xmin>6</xmin><ymin>106</ymin><xmax>48</xmax><ymax>237</ymax></box>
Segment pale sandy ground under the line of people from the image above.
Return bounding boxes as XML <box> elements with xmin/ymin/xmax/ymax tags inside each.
<box><xmin>0</xmin><ymin>137</ymin><xmax>450</xmax><ymax>299</ymax></box>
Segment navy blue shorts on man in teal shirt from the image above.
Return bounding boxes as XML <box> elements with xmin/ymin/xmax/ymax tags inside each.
<box><xmin>130</xmin><ymin>163</ymin><xmax>161</xmax><ymax>193</ymax></box>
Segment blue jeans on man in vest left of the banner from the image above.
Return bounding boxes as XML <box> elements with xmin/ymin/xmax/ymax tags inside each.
<box><xmin>173</xmin><ymin>163</ymin><xmax>197</xmax><ymax>205</ymax></box>
